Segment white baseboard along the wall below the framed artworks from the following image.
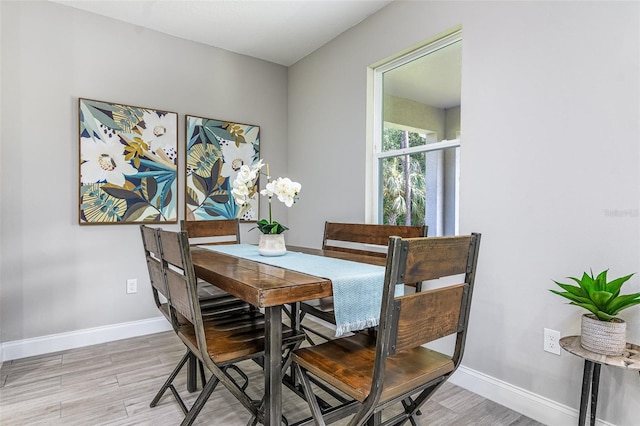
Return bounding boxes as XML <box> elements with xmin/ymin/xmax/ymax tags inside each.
<box><xmin>0</xmin><ymin>317</ymin><xmax>171</xmax><ymax>362</ymax></box>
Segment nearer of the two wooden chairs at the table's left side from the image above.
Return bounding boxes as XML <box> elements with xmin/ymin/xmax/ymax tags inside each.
<box><xmin>158</xmin><ymin>230</ymin><xmax>304</xmax><ymax>425</ymax></box>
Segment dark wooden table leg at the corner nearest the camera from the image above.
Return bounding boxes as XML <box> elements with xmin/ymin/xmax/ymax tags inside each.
<box><xmin>264</xmin><ymin>306</ymin><xmax>282</xmax><ymax>426</ymax></box>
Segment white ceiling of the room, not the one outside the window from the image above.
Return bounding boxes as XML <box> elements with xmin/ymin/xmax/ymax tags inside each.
<box><xmin>50</xmin><ymin>0</ymin><xmax>393</xmax><ymax>66</ymax></box>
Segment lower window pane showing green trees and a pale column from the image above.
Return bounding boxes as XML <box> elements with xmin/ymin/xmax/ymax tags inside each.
<box><xmin>380</xmin><ymin>148</ymin><xmax>458</xmax><ymax>236</ymax></box>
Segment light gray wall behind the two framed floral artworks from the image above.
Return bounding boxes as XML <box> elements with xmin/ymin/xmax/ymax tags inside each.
<box><xmin>0</xmin><ymin>1</ymin><xmax>287</xmax><ymax>342</ymax></box>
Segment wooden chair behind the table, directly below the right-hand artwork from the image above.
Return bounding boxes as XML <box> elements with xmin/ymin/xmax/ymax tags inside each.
<box><xmin>180</xmin><ymin>219</ymin><xmax>252</xmax><ymax>316</ymax></box>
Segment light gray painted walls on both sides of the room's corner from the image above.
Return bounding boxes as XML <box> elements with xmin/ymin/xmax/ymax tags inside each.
<box><xmin>0</xmin><ymin>1</ymin><xmax>640</xmax><ymax>425</ymax></box>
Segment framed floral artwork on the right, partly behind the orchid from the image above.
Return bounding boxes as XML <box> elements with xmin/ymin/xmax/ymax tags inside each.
<box><xmin>185</xmin><ymin>115</ymin><xmax>260</xmax><ymax>221</ymax></box>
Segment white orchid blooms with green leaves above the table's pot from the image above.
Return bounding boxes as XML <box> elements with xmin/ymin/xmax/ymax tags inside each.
<box><xmin>231</xmin><ymin>159</ymin><xmax>302</xmax><ymax>234</ymax></box>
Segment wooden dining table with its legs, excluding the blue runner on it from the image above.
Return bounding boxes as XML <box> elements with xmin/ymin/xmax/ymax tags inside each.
<box><xmin>191</xmin><ymin>246</ymin><xmax>386</xmax><ymax>426</ymax></box>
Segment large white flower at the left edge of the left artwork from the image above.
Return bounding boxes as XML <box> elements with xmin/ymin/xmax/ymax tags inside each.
<box><xmin>80</xmin><ymin>138</ymin><xmax>138</xmax><ymax>186</ymax></box>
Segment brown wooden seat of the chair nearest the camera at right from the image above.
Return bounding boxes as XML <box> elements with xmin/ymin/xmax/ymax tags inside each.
<box><xmin>292</xmin><ymin>333</ymin><xmax>455</xmax><ymax>402</ymax></box>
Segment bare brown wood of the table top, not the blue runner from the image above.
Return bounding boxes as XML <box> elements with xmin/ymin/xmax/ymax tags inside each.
<box><xmin>191</xmin><ymin>246</ymin><xmax>386</xmax><ymax>308</ymax></box>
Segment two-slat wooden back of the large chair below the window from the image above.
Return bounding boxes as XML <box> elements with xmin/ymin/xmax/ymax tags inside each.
<box><xmin>380</xmin><ymin>234</ymin><xmax>480</xmax><ymax>367</ymax></box>
